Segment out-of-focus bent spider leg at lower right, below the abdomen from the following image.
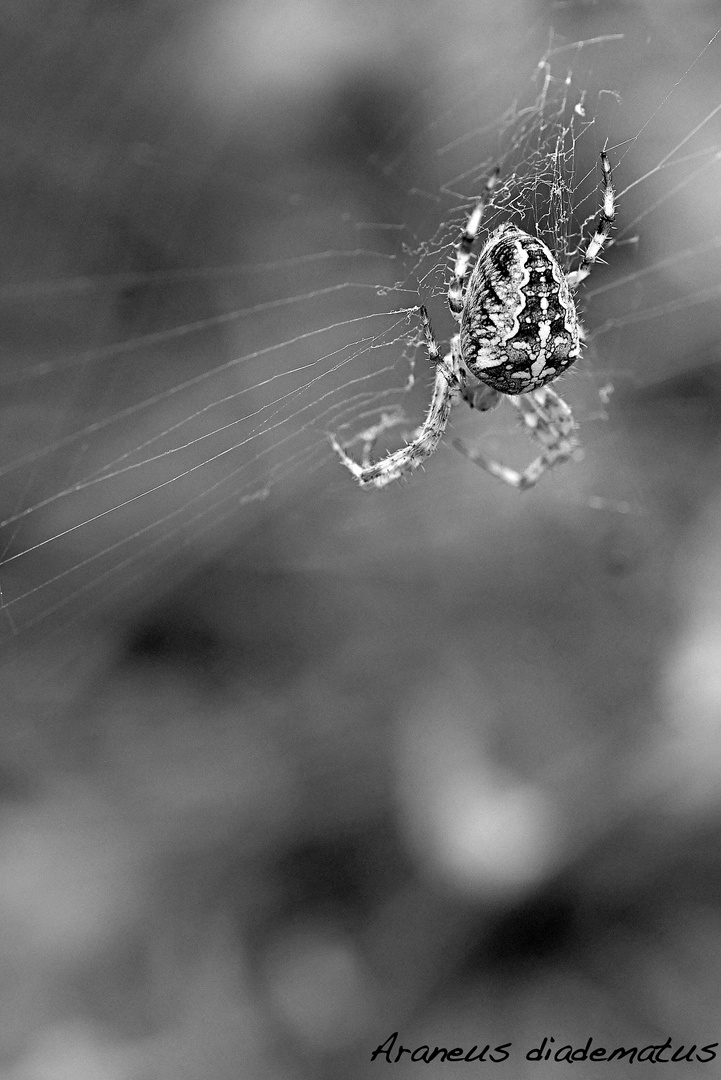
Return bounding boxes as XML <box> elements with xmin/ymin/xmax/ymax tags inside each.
<box><xmin>453</xmin><ymin>387</ymin><xmax>581</xmax><ymax>491</ymax></box>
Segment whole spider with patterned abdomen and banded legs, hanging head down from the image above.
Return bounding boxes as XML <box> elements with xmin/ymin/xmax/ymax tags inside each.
<box><xmin>329</xmin><ymin>151</ymin><xmax>616</xmax><ymax>490</ymax></box>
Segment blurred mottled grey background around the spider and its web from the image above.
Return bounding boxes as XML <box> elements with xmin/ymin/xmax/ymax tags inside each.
<box><xmin>0</xmin><ymin>0</ymin><xmax>721</xmax><ymax>1080</ymax></box>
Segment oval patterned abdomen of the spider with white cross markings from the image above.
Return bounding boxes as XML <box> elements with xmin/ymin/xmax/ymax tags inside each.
<box><xmin>461</xmin><ymin>225</ymin><xmax>581</xmax><ymax>394</ymax></box>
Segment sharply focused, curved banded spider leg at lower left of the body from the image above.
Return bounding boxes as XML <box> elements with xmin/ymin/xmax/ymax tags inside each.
<box><xmin>328</xmin><ymin>307</ymin><xmax>460</xmax><ymax>487</ymax></box>
